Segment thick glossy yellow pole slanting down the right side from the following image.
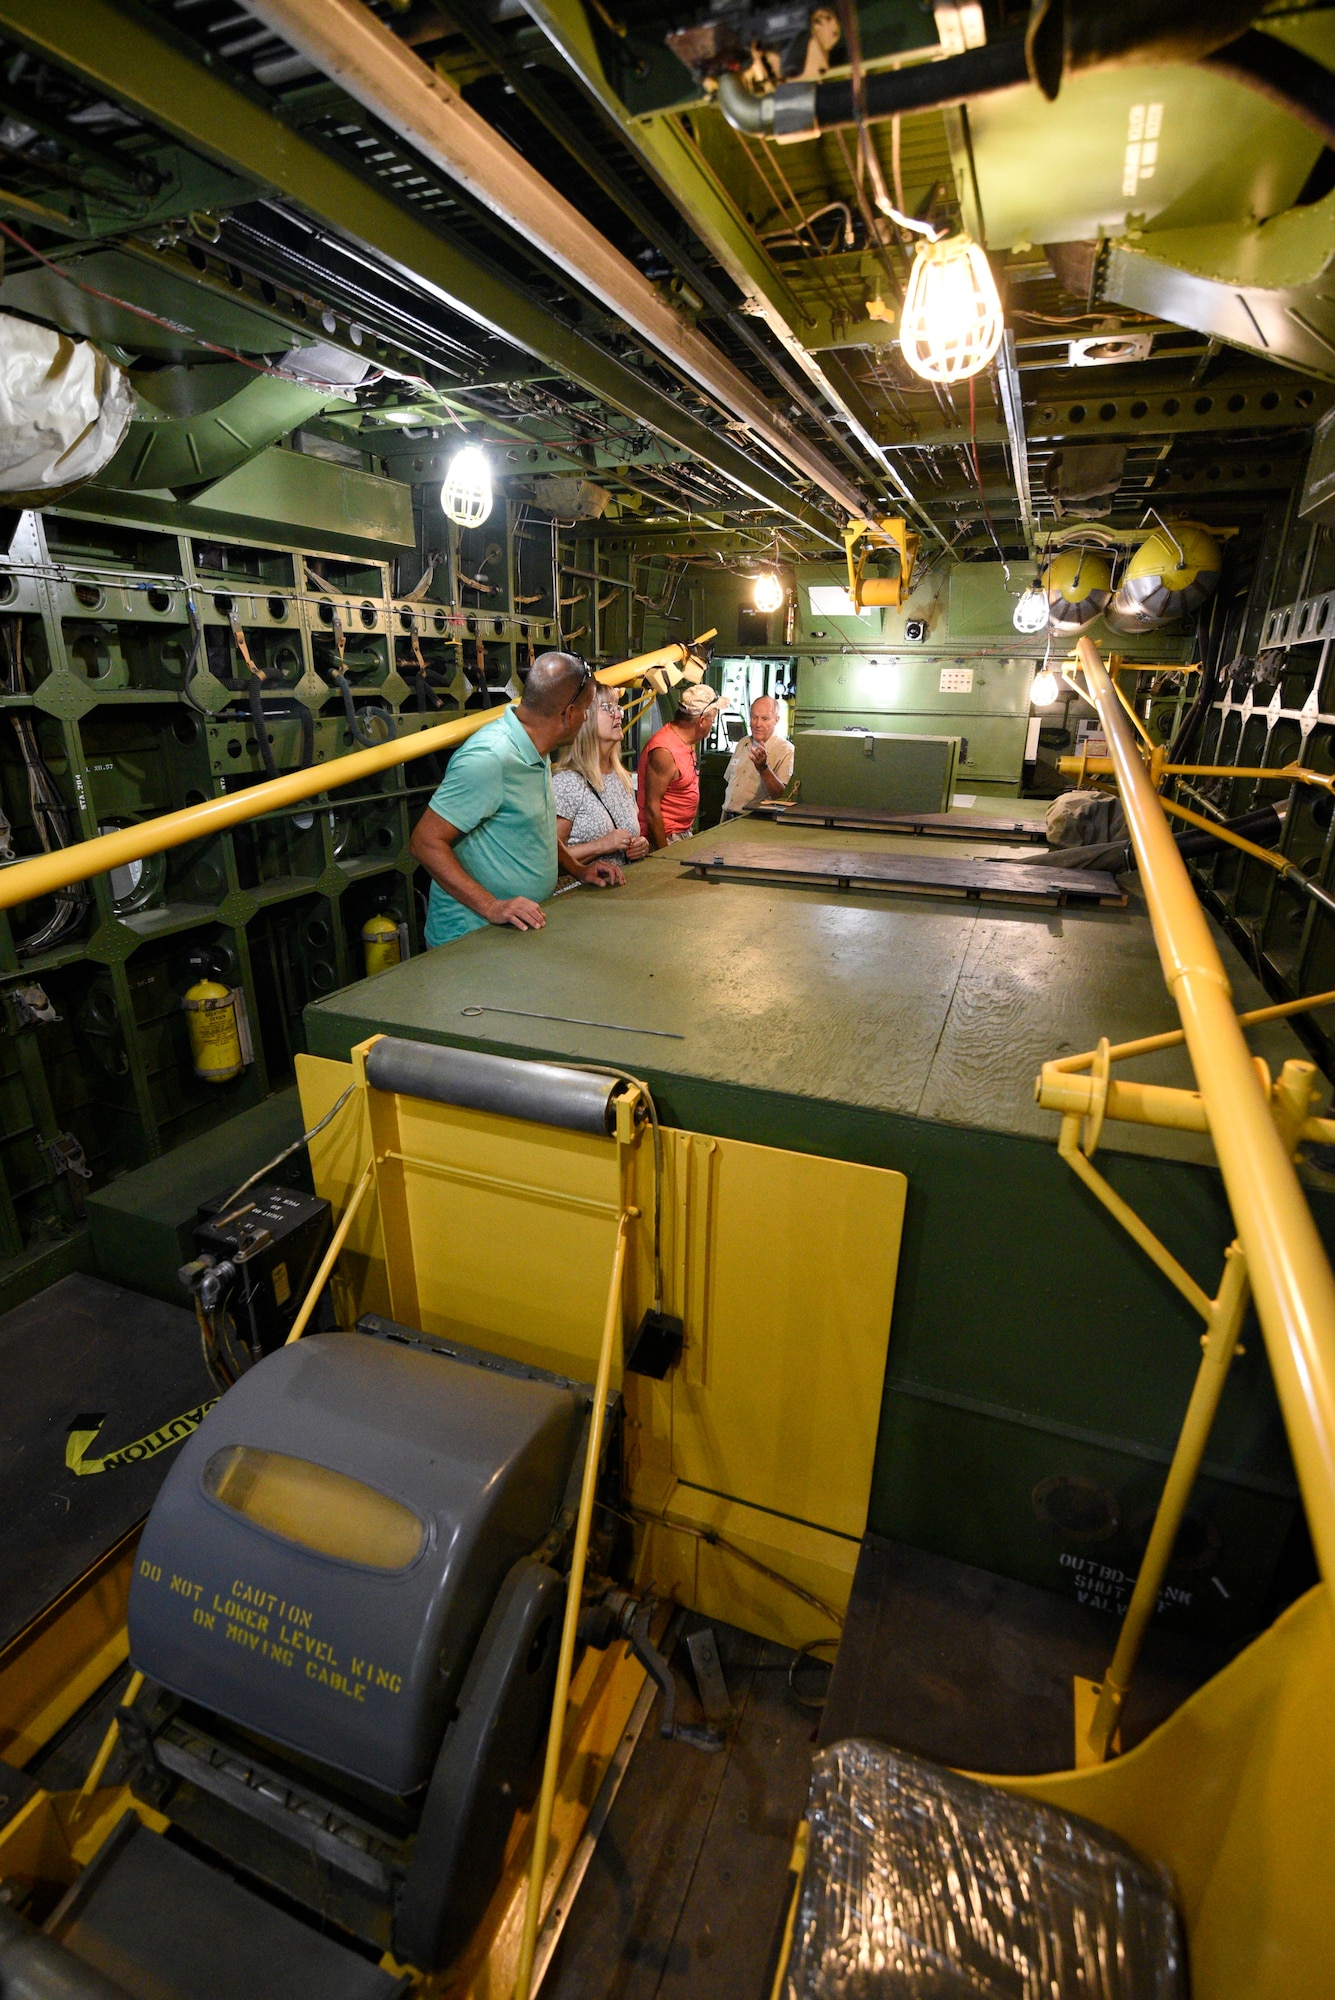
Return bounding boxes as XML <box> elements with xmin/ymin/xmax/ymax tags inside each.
<box><xmin>1077</xmin><ymin>638</ymin><xmax>1335</xmax><ymax>1582</ymax></box>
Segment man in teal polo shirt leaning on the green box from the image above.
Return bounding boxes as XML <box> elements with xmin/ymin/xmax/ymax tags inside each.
<box><xmin>412</xmin><ymin>652</ymin><xmax>626</xmax><ymax>946</ymax></box>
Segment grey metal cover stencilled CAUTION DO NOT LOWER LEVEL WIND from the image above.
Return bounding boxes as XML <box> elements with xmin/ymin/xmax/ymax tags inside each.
<box><xmin>130</xmin><ymin>1334</ymin><xmax>582</xmax><ymax>1794</ymax></box>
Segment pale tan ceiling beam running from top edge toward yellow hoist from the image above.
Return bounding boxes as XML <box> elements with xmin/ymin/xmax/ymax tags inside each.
<box><xmin>246</xmin><ymin>0</ymin><xmax>869</xmax><ymax>514</ymax></box>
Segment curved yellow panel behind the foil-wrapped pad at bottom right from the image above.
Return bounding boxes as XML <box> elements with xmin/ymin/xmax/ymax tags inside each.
<box><xmin>991</xmin><ymin>1584</ymin><xmax>1335</xmax><ymax>2000</ymax></box>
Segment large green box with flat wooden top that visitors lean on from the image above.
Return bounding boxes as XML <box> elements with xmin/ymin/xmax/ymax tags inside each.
<box><xmin>306</xmin><ymin>800</ymin><xmax>1335</xmax><ymax>1636</ymax></box>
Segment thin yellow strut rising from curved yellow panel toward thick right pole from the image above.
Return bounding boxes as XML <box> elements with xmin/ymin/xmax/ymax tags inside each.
<box><xmin>1089</xmin><ymin>1244</ymin><xmax>1251</xmax><ymax>1762</ymax></box>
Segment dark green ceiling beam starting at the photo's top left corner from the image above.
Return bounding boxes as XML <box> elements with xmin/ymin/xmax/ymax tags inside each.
<box><xmin>0</xmin><ymin>0</ymin><xmax>833</xmax><ymax>540</ymax></box>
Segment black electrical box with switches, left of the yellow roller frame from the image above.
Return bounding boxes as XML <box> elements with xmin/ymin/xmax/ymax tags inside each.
<box><xmin>194</xmin><ymin>1184</ymin><xmax>332</xmax><ymax>1360</ymax></box>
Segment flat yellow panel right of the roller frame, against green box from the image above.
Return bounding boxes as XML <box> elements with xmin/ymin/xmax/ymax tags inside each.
<box><xmin>628</xmin><ymin>1132</ymin><xmax>907</xmax><ymax>1538</ymax></box>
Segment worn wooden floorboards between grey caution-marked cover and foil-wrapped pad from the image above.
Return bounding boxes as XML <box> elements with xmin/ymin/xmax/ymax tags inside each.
<box><xmin>542</xmin><ymin>1618</ymin><xmax>815</xmax><ymax>2000</ymax></box>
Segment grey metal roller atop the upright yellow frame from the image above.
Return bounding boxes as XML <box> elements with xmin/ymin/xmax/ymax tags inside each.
<box><xmin>366</xmin><ymin>1034</ymin><xmax>622</xmax><ymax>1138</ymax></box>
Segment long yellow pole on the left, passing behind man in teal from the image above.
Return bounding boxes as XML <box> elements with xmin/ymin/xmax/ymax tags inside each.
<box><xmin>0</xmin><ymin>632</ymin><xmax>713</xmax><ymax>910</ymax></box>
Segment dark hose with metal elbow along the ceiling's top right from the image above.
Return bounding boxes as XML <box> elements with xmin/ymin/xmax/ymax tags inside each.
<box><xmin>717</xmin><ymin>0</ymin><xmax>1335</xmax><ymax>146</ymax></box>
